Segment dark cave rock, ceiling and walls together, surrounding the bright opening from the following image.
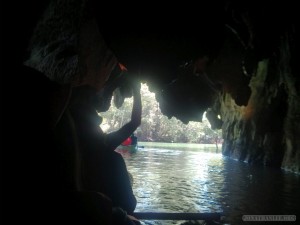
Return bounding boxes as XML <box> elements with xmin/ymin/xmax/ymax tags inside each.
<box><xmin>3</xmin><ymin>0</ymin><xmax>300</xmax><ymax>223</ymax></box>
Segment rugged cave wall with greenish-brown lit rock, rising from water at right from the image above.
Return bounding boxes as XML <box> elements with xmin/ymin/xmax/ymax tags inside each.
<box><xmin>214</xmin><ymin>34</ymin><xmax>300</xmax><ymax>173</ymax></box>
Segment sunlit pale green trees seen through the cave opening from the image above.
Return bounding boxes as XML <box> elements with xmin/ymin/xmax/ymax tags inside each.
<box><xmin>100</xmin><ymin>84</ymin><xmax>222</xmax><ymax>144</ymax></box>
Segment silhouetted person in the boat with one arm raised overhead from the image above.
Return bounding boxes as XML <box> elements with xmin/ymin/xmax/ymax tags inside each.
<box><xmin>70</xmin><ymin>78</ymin><xmax>142</xmax><ymax>214</ymax></box>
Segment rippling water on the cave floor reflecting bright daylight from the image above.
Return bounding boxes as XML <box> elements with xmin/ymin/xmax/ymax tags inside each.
<box><xmin>120</xmin><ymin>145</ymin><xmax>300</xmax><ymax>224</ymax></box>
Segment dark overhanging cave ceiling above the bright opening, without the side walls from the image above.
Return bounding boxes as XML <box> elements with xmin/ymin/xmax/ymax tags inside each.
<box><xmin>92</xmin><ymin>1</ymin><xmax>292</xmax><ymax>123</ymax></box>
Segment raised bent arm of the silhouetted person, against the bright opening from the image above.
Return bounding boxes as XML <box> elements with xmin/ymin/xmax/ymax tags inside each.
<box><xmin>106</xmin><ymin>83</ymin><xmax>142</xmax><ymax>150</ymax></box>
